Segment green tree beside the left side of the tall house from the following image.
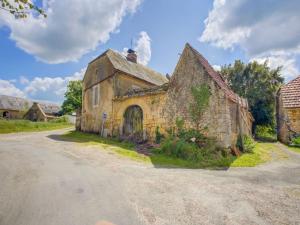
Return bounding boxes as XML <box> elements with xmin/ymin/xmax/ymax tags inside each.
<box><xmin>62</xmin><ymin>80</ymin><xmax>82</xmax><ymax>114</ymax></box>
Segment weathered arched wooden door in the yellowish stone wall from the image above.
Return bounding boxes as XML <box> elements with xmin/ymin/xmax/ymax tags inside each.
<box><xmin>123</xmin><ymin>105</ymin><xmax>143</xmax><ymax>138</ymax></box>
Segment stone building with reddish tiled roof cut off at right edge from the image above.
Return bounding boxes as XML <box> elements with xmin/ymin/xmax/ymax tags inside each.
<box><xmin>277</xmin><ymin>76</ymin><xmax>300</xmax><ymax>143</ymax></box>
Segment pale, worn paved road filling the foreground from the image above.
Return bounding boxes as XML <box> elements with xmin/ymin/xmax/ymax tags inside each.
<box><xmin>0</xmin><ymin>128</ymin><xmax>300</xmax><ymax>225</ymax></box>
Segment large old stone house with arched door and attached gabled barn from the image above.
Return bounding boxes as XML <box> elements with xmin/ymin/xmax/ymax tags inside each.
<box><xmin>81</xmin><ymin>44</ymin><xmax>253</xmax><ymax>147</ymax></box>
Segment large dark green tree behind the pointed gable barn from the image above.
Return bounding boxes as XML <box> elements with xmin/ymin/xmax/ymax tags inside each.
<box><xmin>221</xmin><ymin>60</ymin><xmax>284</xmax><ymax>131</ymax></box>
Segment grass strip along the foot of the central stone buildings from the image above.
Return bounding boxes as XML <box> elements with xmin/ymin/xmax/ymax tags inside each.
<box><xmin>61</xmin><ymin>131</ymin><xmax>288</xmax><ymax>168</ymax></box>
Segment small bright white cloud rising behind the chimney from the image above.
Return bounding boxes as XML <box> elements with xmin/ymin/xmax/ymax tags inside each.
<box><xmin>121</xmin><ymin>31</ymin><xmax>151</xmax><ymax>65</ymax></box>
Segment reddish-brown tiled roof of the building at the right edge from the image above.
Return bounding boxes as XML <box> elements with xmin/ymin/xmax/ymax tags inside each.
<box><xmin>280</xmin><ymin>76</ymin><xmax>300</xmax><ymax>108</ymax></box>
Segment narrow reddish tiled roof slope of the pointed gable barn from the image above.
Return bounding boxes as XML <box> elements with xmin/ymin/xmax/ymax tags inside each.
<box><xmin>186</xmin><ymin>43</ymin><xmax>248</xmax><ymax>107</ymax></box>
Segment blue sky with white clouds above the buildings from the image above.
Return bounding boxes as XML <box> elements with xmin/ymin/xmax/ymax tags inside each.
<box><xmin>0</xmin><ymin>0</ymin><xmax>300</xmax><ymax>103</ymax></box>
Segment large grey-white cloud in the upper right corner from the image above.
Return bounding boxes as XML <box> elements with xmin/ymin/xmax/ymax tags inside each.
<box><xmin>199</xmin><ymin>0</ymin><xmax>300</xmax><ymax>79</ymax></box>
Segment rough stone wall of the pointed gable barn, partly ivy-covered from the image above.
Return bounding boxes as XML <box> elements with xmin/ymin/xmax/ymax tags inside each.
<box><xmin>164</xmin><ymin>43</ymin><xmax>251</xmax><ymax>147</ymax></box>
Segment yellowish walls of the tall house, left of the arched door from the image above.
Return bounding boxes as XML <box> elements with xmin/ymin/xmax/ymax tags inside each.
<box><xmin>81</xmin><ymin>69</ymin><xmax>157</xmax><ymax>135</ymax></box>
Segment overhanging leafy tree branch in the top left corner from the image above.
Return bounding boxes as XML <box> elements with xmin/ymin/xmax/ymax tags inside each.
<box><xmin>0</xmin><ymin>0</ymin><xmax>47</xmax><ymax>18</ymax></box>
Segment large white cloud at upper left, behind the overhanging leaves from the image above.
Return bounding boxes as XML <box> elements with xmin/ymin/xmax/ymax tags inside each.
<box><xmin>0</xmin><ymin>0</ymin><xmax>142</xmax><ymax>63</ymax></box>
